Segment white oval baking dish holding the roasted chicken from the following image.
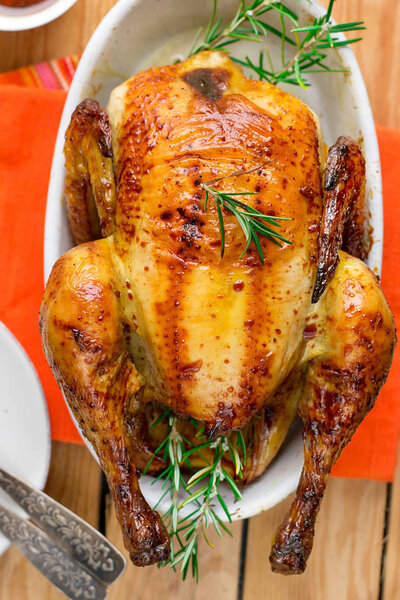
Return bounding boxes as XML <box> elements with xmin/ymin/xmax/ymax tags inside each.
<box><xmin>45</xmin><ymin>0</ymin><xmax>383</xmax><ymax>519</ymax></box>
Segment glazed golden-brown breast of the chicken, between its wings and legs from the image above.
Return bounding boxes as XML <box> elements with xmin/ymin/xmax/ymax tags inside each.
<box><xmin>108</xmin><ymin>53</ymin><xmax>322</xmax><ymax>436</ymax></box>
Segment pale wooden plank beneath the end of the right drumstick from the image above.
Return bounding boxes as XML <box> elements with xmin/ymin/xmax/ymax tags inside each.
<box><xmin>243</xmin><ymin>479</ymin><xmax>392</xmax><ymax>600</ymax></box>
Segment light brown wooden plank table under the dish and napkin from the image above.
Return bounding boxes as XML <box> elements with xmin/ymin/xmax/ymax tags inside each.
<box><xmin>0</xmin><ymin>0</ymin><xmax>400</xmax><ymax>600</ymax></box>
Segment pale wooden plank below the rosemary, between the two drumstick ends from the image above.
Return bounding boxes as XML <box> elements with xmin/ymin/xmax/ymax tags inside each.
<box><xmin>106</xmin><ymin>502</ymin><xmax>243</xmax><ymax>600</ymax></box>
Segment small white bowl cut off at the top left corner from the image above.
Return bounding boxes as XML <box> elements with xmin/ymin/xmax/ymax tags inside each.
<box><xmin>0</xmin><ymin>0</ymin><xmax>77</xmax><ymax>31</ymax></box>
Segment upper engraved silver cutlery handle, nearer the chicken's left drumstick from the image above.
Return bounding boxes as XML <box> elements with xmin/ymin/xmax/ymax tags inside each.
<box><xmin>0</xmin><ymin>468</ymin><xmax>126</xmax><ymax>584</ymax></box>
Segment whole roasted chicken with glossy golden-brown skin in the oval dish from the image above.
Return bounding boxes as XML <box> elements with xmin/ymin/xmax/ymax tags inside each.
<box><xmin>40</xmin><ymin>52</ymin><xmax>396</xmax><ymax>573</ymax></box>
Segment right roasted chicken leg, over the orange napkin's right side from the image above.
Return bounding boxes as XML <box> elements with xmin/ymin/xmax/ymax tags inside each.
<box><xmin>270</xmin><ymin>251</ymin><xmax>396</xmax><ymax>574</ymax></box>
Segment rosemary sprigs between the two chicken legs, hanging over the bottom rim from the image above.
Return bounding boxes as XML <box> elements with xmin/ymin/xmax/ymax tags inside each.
<box><xmin>145</xmin><ymin>409</ymin><xmax>246</xmax><ymax>581</ymax></box>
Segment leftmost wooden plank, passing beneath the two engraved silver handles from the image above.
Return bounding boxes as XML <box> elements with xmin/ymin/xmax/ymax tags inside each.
<box><xmin>0</xmin><ymin>442</ymin><xmax>100</xmax><ymax>600</ymax></box>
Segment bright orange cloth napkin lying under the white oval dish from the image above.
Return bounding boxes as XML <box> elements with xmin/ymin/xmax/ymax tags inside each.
<box><xmin>0</xmin><ymin>85</ymin><xmax>400</xmax><ymax>481</ymax></box>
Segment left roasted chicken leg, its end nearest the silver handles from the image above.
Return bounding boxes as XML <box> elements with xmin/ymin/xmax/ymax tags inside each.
<box><xmin>40</xmin><ymin>239</ymin><xmax>169</xmax><ymax>566</ymax></box>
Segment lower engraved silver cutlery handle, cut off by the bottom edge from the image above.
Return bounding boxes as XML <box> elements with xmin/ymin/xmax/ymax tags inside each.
<box><xmin>0</xmin><ymin>506</ymin><xmax>107</xmax><ymax>600</ymax></box>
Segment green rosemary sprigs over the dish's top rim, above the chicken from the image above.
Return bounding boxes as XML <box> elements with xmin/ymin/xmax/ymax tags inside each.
<box><xmin>189</xmin><ymin>0</ymin><xmax>365</xmax><ymax>88</ymax></box>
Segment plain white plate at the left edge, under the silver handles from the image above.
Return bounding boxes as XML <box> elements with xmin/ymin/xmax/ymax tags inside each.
<box><xmin>0</xmin><ymin>322</ymin><xmax>51</xmax><ymax>555</ymax></box>
